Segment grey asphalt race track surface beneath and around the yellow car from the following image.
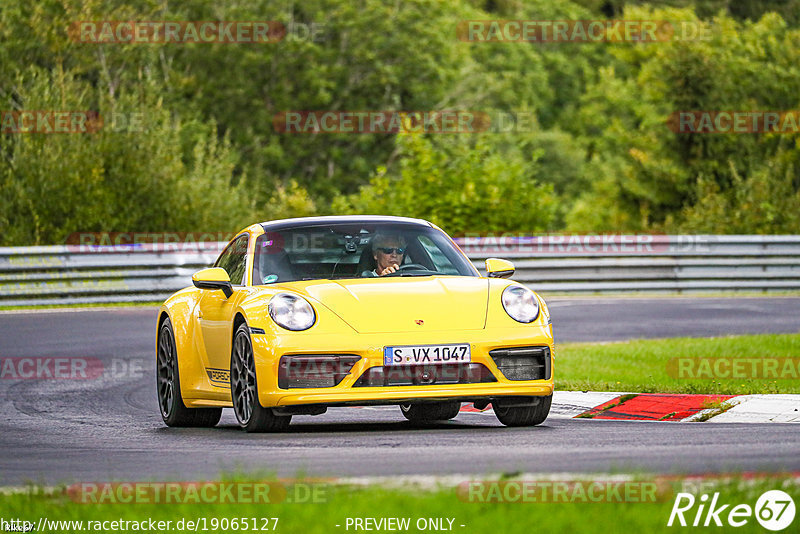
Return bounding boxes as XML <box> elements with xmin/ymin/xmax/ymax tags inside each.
<box><xmin>0</xmin><ymin>297</ymin><xmax>800</xmax><ymax>485</ymax></box>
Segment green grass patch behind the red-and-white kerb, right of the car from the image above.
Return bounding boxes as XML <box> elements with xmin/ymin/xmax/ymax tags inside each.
<box><xmin>555</xmin><ymin>334</ymin><xmax>800</xmax><ymax>395</ymax></box>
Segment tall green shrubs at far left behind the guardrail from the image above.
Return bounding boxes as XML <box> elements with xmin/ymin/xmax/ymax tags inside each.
<box><xmin>0</xmin><ymin>68</ymin><xmax>252</xmax><ymax>244</ymax></box>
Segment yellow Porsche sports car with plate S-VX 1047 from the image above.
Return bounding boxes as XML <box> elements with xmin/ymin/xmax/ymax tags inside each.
<box><xmin>156</xmin><ymin>216</ymin><xmax>553</xmax><ymax>432</ymax></box>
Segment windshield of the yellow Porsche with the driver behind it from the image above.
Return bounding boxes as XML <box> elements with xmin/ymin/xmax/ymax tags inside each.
<box><xmin>253</xmin><ymin>223</ymin><xmax>479</xmax><ymax>285</ymax></box>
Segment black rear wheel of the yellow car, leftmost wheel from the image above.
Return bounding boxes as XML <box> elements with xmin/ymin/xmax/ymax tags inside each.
<box><xmin>156</xmin><ymin>318</ymin><xmax>222</xmax><ymax>427</ymax></box>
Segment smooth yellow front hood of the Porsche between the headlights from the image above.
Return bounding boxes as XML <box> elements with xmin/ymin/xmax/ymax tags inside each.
<box><xmin>292</xmin><ymin>276</ymin><xmax>489</xmax><ymax>333</ymax></box>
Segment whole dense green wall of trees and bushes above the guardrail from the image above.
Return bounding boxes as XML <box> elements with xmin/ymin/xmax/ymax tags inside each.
<box><xmin>0</xmin><ymin>0</ymin><xmax>800</xmax><ymax>245</ymax></box>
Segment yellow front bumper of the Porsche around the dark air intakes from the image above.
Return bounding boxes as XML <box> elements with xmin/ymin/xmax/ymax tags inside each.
<box><xmin>252</xmin><ymin>326</ymin><xmax>554</xmax><ymax>407</ymax></box>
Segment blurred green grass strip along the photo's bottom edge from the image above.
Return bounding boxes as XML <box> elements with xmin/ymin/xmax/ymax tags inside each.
<box><xmin>0</xmin><ymin>475</ymin><xmax>800</xmax><ymax>534</ymax></box>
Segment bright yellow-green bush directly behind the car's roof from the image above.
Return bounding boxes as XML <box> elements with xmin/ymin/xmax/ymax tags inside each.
<box><xmin>333</xmin><ymin>134</ymin><xmax>556</xmax><ymax>234</ymax></box>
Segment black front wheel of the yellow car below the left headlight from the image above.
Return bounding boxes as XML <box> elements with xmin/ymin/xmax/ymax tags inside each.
<box><xmin>231</xmin><ymin>324</ymin><xmax>292</xmax><ymax>432</ymax></box>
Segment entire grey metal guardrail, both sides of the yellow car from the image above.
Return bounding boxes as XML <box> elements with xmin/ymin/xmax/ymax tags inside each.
<box><xmin>0</xmin><ymin>235</ymin><xmax>800</xmax><ymax>306</ymax></box>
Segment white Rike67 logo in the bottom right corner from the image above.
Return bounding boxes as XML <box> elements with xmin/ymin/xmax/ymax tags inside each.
<box><xmin>667</xmin><ymin>490</ymin><xmax>795</xmax><ymax>531</ymax></box>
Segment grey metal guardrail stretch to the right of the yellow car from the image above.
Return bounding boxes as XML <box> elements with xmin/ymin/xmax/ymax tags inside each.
<box><xmin>459</xmin><ymin>235</ymin><xmax>800</xmax><ymax>293</ymax></box>
